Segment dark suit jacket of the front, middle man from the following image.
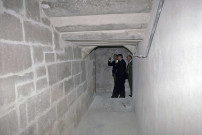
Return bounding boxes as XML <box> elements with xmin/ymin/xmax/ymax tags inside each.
<box><xmin>116</xmin><ymin>59</ymin><xmax>126</xmax><ymax>79</ymax></box>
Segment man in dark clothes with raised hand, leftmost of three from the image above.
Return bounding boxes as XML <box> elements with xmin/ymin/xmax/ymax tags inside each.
<box><xmin>108</xmin><ymin>54</ymin><xmax>118</xmax><ymax>98</ymax></box>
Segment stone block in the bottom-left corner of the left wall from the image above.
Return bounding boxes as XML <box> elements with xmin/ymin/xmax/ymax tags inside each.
<box><xmin>0</xmin><ymin>111</ymin><xmax>18</xmax><ymax>135</ymax></box>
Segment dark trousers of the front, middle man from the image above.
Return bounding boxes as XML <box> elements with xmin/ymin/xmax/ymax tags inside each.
<box><xmin>112</xmin><ymin>78</ymin><xmax>125</xmax><ymax>98</ymax></box>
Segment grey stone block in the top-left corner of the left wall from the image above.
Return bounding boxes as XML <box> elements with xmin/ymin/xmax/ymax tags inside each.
<box><xmin>2</xmin><ymin>0</ymin><xmax>23</xmax><ymax>13</ymax></box>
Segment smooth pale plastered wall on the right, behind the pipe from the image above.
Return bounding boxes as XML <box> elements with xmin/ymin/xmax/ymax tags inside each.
<box><xmin>133</xmin><ymin>0</ymin><xmax>202</xmax><ymax>135</ymax></box>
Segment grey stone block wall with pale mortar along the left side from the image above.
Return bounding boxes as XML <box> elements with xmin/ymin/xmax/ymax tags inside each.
<box><xmin>0</xmin><ymin>0</ymin><xmax>95</xmax><ymax>135</ymax></box>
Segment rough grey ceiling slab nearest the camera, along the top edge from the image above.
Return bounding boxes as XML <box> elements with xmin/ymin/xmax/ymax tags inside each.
<box><xmin>43</xmin><ymin>0</ymin><xmax>152</xmax><ymax>16</ymax></box>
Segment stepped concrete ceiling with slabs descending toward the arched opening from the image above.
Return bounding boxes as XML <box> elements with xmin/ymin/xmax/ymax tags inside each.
<box><xmin>41</xmin><ymin>0</ymin><xmax>152</xmax><ymax>54</ymax></box>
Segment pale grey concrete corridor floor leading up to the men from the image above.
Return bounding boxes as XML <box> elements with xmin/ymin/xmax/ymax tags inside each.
<box><xmin>74</xmin><ymin>92</ymin><xmax>140</xmax><ymax>135</ymax></box>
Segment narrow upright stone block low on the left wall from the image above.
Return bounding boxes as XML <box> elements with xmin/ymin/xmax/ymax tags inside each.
<box><xmin>19</xmin><ymin>103</ymin><xmax>27</xmax><ymax>129</ymax></box>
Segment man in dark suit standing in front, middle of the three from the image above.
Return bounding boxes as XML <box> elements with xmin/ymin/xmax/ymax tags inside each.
<box><xmin>113</xmin><ymin>54</ymin><xmax>126</xmax><ymax>98</ymax></box>
